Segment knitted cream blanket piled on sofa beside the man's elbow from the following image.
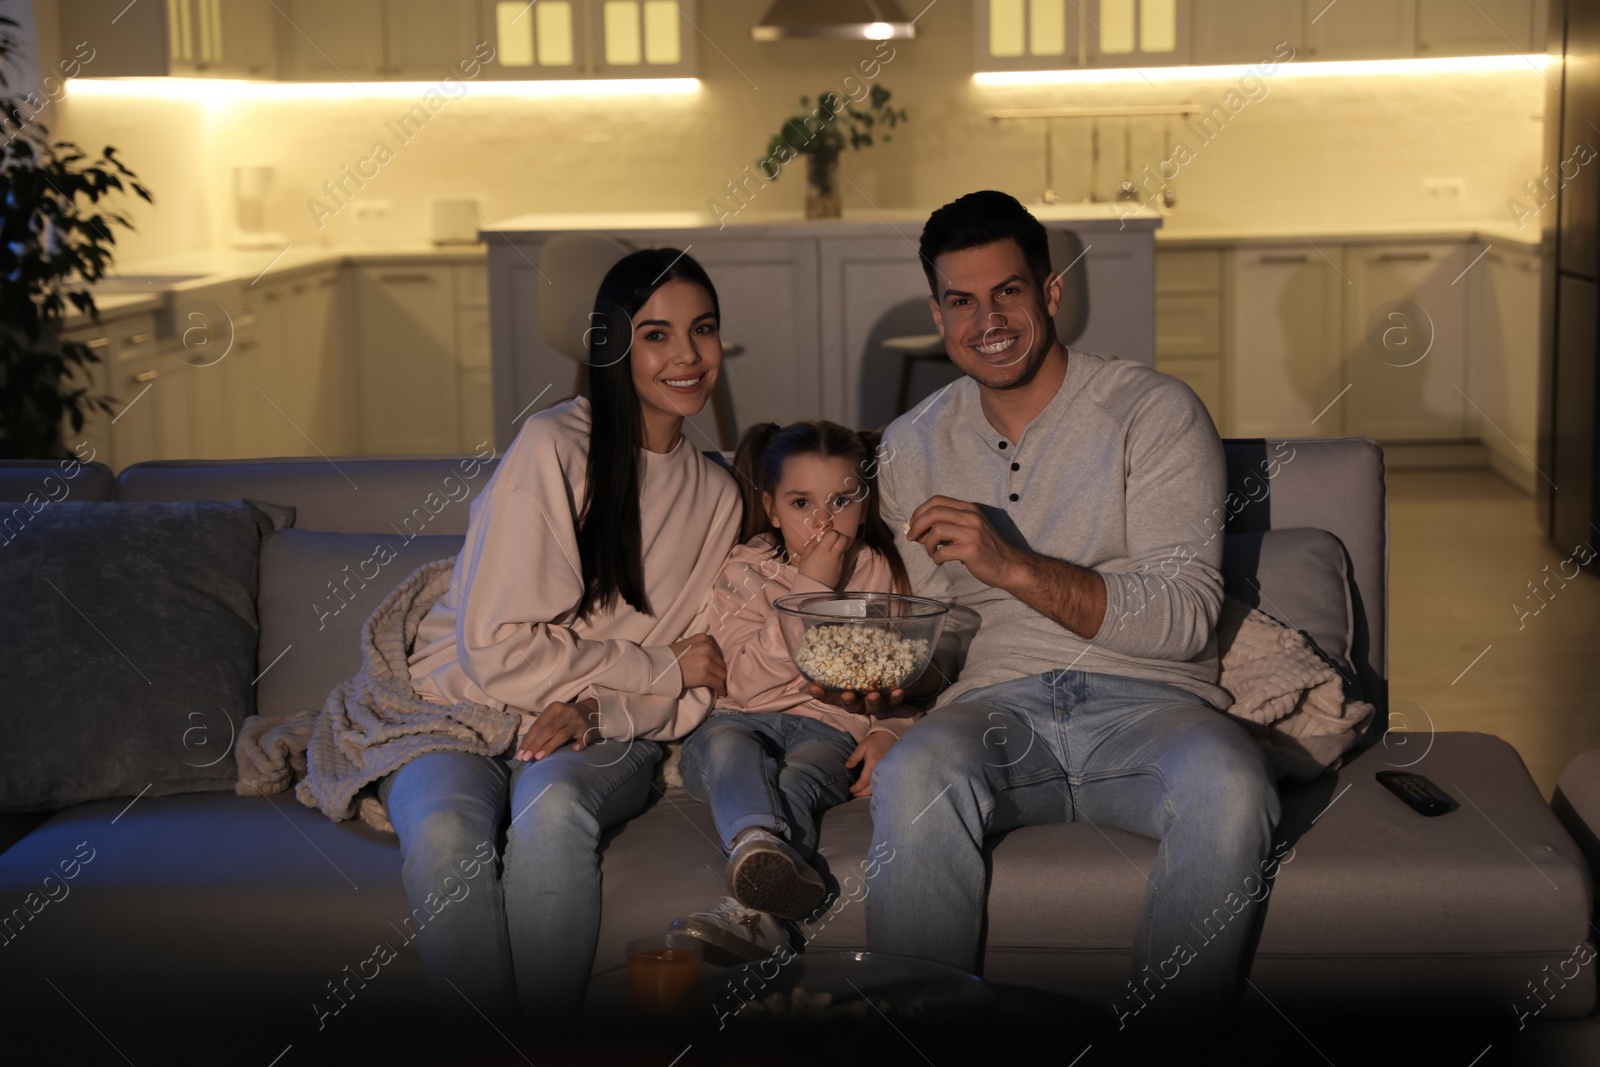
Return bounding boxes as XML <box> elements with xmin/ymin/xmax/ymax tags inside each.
<box><xmin>1216</xmin><ymin>597</ymin><xmax>1378</xmax><ymax>781</ymax></box>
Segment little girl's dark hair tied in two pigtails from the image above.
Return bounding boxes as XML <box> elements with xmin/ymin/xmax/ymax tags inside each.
<box><xmin>733</xmin><ymin>419</ymin><xmax>910</xmax><ymax>593</ymax></box>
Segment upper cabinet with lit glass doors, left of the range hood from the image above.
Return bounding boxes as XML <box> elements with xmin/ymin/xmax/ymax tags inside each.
<box><xmin>477</xmin><ymin>0</ymin><xmax>696</xmax><ymax>78</ymax></box>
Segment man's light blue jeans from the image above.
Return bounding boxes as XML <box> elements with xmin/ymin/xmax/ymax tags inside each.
<box><xmin>867</xmin><ymin>670</ymin><xmax>1278</xmax><ymax>1021</ymax></box>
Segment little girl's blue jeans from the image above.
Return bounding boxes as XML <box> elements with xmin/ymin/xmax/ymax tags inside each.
<box><xmin>678</xmin><ymin>710</ymin><xmax>856</xmax><ymax>861</ymax></box>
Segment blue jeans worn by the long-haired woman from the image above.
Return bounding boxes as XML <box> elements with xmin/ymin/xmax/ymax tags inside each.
<box><xmin>378</xmin><ymin>739</ymin><xmax>661</xmax><ymax>1021</ymax></box>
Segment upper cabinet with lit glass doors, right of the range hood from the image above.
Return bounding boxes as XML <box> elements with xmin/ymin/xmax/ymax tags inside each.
<box><xmin>973</xmin><ymin>0</ymin><xmax>1190</xmax><ymax>70</ymax></box>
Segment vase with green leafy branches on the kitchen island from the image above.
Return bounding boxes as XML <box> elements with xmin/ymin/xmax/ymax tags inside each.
<box><xmin>760</xmin><ymin>85</ymin><xmax>906</xmax><ymax>219</ymax></box>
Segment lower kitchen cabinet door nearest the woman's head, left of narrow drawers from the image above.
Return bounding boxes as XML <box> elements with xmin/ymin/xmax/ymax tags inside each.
<box><xmin>355</xmin><ymin>266</ymin><xmax>461</xmax><ymax>454</ymax></box>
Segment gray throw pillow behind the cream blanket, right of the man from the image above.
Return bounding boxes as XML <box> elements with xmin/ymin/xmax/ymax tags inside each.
<box><xmin>1219</xmin><ymin>526</ymin><xmax>1365</xmax><ymax>699</ymax></box>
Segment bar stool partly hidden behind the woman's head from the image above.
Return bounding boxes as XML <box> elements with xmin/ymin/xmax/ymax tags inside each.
<box><xmin>539</xmin><ymin>234</ymin><xmax>744</xmax><ymax>451</ymax></box>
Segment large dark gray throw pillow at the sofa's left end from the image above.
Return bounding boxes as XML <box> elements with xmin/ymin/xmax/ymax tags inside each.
<box><xmin>0</xmin><ymin>501</ymin><xmax>294</xmax><ymax>811</ymax></box>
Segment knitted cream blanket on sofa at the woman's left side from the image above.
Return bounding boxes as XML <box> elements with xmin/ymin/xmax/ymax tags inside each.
<box><xmin>234</xmin><ymin>557</ymin><xmax>522</xmax><ymax>833</ymax></box>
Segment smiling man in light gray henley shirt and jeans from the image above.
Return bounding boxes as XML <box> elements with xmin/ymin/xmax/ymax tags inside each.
<box><xmin>867</xmin><ymin>192</ymin><xmax>1278</xmax><ymax>1019</ymax></box>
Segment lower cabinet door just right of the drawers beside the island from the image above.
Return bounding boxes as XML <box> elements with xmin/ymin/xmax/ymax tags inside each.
<box><xmin>1224</xmin><ymin>245</ymin><xmax>1346</xmax><ymax>437</ymax></box>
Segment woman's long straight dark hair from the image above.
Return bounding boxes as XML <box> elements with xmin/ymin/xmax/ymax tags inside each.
<box><xmin>576</xmin><ymin>248</ymin><xmax>722</xmax><ymax>619</ymax></box>
